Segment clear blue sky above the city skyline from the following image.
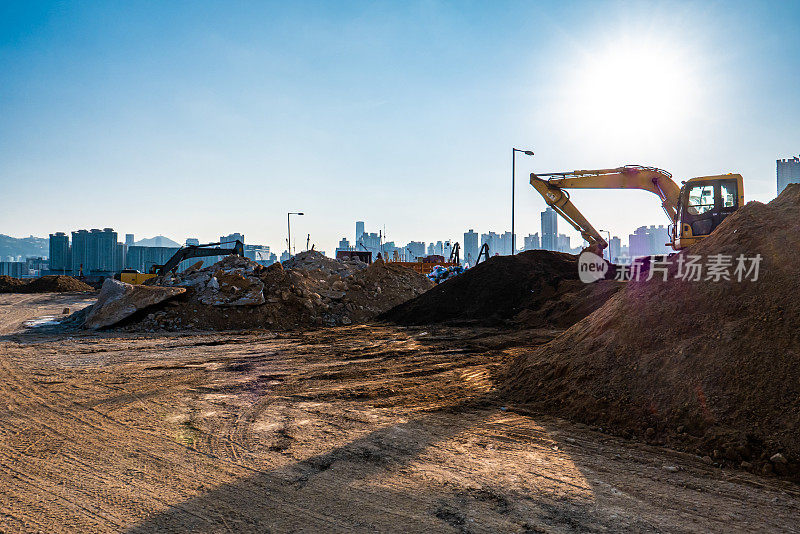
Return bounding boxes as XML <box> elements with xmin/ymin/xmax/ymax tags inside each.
<box><xmin>0</xmin><ymin>1</ymin><xmax>800</xmax><ymax>252</ymax></box>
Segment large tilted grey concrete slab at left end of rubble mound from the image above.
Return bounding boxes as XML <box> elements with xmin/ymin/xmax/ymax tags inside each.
<box><xmin>83</xmin><ymin>278</ymin><xmax>186</xmax><ymax>330</ymax></box>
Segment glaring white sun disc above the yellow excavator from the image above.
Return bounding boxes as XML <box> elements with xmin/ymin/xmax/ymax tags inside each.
<box><xmin>562</xmin><ymin>39</ymin><xmax>699</xmax><ymax>147</ymax></box>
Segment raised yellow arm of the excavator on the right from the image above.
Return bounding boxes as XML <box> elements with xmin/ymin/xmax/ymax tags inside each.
<box><xmin>531</xmin><ymin>165</ymin><xmax>680</xmax><ymax>251</ymax></box>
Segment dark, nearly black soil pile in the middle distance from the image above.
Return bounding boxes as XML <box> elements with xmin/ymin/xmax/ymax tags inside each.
<box><xmin>380</xmin><ymin>250</ymin><xmax>620</xmax><ymax>327</ymax></box>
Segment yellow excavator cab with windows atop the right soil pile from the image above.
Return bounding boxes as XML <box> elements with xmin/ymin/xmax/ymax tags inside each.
<box><xmin>671</xmin><ymin>174</ymin><xmax>744</xmax><ymax>250</ymax></box>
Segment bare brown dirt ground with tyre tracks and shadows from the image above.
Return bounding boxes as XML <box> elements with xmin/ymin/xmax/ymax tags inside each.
<box><xmin>0</xmin><ymin>294</ymin><xmax>800</xmax><ymax>532</ymax></box>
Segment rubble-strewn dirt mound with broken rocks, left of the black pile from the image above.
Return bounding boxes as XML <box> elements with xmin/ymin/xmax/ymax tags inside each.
<box><xmin>120</xmin><ymin>253</ymin><xmax>433</xmax><ymax>330</ymax></box>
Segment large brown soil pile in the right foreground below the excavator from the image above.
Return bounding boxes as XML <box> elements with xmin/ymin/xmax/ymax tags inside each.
<box><xmin>509</xmin><ymin>185</ymin><xmax>800</xmax><ymax>476</ymax></box>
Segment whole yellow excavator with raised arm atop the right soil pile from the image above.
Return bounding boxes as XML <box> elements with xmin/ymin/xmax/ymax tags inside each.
<box><xmin>531</xmin><ymin>165</ymin><xmax>744</xmax><ymax>255</ymax></box>
